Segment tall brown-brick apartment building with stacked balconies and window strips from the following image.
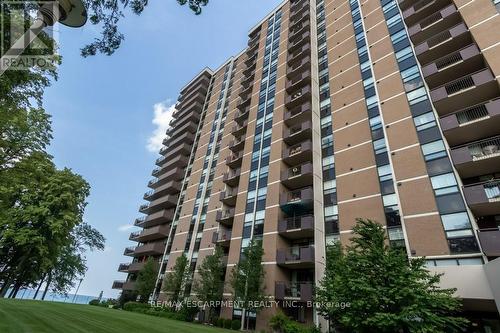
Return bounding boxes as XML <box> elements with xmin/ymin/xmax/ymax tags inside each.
<box><xmin>113</xmin><ymin>0</ymin><xmax>500</xmax><ymax>332</ymax></box>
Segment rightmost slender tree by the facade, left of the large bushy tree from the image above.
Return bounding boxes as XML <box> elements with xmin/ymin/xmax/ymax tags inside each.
<box><xmin>230</xmin><ymin>239</ymin><xmax>267</xmax><ymax>329</ymax></box>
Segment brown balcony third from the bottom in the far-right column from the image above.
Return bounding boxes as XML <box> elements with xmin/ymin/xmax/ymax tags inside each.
<box><xmin>451</xmin><ymin>136</ymin><xmax>500</xmax><ymax>178</ymax></box>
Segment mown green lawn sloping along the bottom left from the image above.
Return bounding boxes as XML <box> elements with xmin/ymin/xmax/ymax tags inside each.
<box><xmin>0</xmin><ymin>298</ymin><xmax>230</xmax><ymax>333</ymax></box>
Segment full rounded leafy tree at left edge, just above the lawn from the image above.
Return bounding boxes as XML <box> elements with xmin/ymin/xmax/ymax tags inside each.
<box><xmin>0</xmin><ymin>153</ymin><xmax>89</xmax><ymax>297</ymax></box>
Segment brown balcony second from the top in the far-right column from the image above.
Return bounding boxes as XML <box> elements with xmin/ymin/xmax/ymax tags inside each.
<box><xmin>408</xmin><ymin>4</ymin><xmax>461</xmax><ymax>44</ymax></box>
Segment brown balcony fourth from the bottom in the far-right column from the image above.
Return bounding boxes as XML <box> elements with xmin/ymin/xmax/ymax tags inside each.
<box><xmin>440</xmin><ymin>99</ymin><xmax>500</xmax><ymax>146</ymax></box>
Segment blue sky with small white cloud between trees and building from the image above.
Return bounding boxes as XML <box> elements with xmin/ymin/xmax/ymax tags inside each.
<box><xmin>44</xmin><ymin>0</ymin><xmax>281</xmax><ymax>297</ymax></box>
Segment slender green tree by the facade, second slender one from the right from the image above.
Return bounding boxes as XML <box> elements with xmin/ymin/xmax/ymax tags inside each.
<box><xmin>193</xmin><ymin>246</ymin><xmax>226</xmax><ymax>321</ymax></box>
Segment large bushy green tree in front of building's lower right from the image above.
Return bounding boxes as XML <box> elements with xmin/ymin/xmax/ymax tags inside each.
<box><xmin>316</xmin><ymin>219</ymin><xmax>467</xmax><ymax>333</ymax></box>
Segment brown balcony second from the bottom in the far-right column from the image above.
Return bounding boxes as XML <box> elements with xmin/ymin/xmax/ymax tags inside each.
<box><xmin>464</xmin><ymin>179</ymin><xmax>500</xmax><ymax>216</ymax></box>
